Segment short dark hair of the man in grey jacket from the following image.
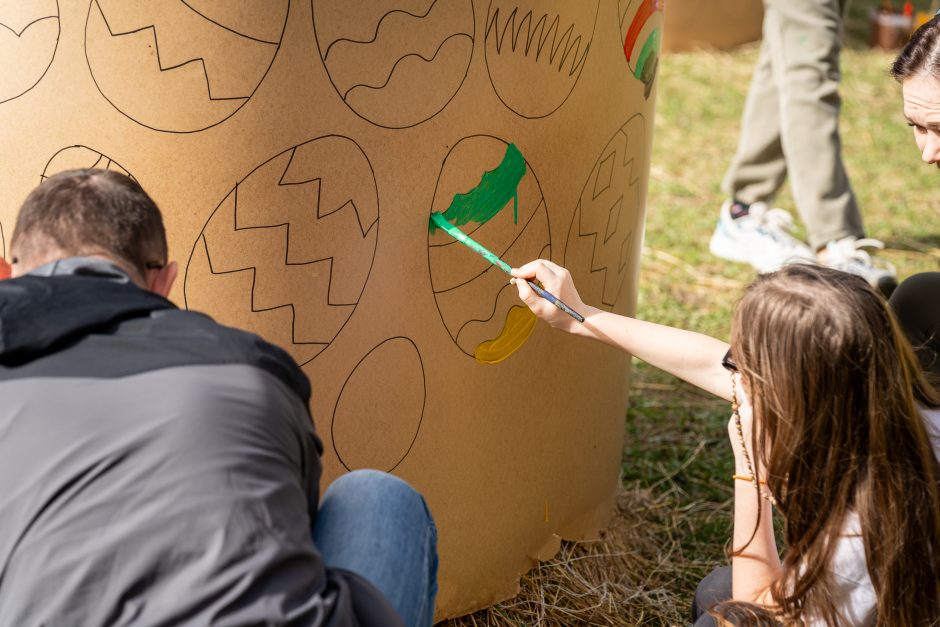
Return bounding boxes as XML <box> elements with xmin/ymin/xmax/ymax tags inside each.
<box><xmin>10</xmin><ymin>169</ymin><xmax>167</xmax><ymax>275</ymax></box>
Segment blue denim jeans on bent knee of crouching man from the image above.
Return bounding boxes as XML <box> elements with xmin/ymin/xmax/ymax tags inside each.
<box><xmin>313</xmin><ymin>470</ymin><xmax>437</xmax><ymax>627</ymax></box>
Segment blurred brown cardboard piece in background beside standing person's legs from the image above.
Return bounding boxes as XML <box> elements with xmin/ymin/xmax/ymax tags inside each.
<box><xmin>663</xmin><ymin>0</ymin><xmax>764</xmax><ymax>52</ymax></box>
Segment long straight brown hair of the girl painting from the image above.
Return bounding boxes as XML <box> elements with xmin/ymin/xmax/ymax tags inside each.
<box><xmin>731</xmin><ymin>264</ymin><xmax>940</xmax><ymax>627</ymax></box>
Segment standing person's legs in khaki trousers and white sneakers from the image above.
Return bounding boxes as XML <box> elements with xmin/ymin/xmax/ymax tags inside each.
<box><xmin>709</xmin><ymin>0</ymin><xmax>897</xmax><ymax>294</ymax></box>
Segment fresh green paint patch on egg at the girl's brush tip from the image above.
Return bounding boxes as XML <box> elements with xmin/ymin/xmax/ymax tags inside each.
<box><xmin>428</xmin><ymin>144</ymin><xmax>526</xmax><ymax>233</ymax></box>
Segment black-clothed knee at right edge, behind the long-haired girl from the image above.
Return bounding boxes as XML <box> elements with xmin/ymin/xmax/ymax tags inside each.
<box><xmin>889</xmin><ymin>272</ymin><xmax>940</xmax><ymax>384</ymax></box>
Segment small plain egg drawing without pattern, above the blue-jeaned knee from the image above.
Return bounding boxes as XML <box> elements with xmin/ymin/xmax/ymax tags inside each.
<box><xmin>330</xmin><ymin>337</ymin><xmax>427</xmax><ymax>472</ymax></box>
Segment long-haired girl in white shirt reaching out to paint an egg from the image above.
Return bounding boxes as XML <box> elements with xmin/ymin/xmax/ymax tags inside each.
<box><xmin>513</xmin><ymin>260</ymin><xmax>940</xmax><ymax>627</ymax></box>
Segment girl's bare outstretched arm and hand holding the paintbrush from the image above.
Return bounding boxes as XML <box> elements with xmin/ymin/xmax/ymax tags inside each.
<box><xmin>512</xmin><ymin>259</ymin><xmax>731</xmax><ymax>400</ymax></box>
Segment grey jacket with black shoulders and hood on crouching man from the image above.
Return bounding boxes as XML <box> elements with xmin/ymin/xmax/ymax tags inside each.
<box><xmin>0</xmin><ymin>259</ymin><xmax>400</xmax><ymax>627</ymax></box>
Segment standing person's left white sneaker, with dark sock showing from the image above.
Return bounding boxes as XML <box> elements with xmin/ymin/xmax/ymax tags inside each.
<box><xmin>708</xmin><ymin>200</ymin><xmax>816</xmax><ymax>272</ymax></box>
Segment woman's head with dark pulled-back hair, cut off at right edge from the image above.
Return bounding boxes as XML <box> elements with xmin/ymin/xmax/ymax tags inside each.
<box><xmin>891</xmin><ymin>16</ymin><xmax>940</xmax><ymax>167</ymax></box>
